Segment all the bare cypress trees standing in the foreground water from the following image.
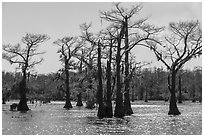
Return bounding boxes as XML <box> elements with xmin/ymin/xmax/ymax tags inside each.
<box><xmin>3</xmin><ymin>3</ymin><xmax>202</xmax><ymax>118</ymax></box>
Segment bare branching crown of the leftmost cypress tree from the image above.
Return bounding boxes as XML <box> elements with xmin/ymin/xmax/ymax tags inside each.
<box><xmin>3</xmin><ymin>33</ymin><xmax>49</xmax><ymax>72</ymax></box>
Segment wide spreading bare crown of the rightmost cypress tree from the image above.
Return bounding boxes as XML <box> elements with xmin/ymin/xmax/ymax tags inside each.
<box><xmin>147</xmin><ymin>21</ymin><xmax>202</xmax><ymax>73</ymax></box>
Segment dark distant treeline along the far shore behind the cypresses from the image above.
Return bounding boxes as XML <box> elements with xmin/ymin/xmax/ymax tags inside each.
<box><xmin>2</xmin><ymin>67</ymin><xmax>202</xmax><ymax>102</ymax></box>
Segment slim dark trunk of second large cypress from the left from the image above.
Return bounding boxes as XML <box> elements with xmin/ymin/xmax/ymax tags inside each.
<box><xmin>64</xmin><ymin>61</ymin><xmax>72</xmax><ymax>109</ymax></box>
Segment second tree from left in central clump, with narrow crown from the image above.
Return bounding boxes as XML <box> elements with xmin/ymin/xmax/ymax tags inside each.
<box><xmin>99</xmin><ymin>25</ymin><xmax>119</xmax><ymax>118</ymax></box>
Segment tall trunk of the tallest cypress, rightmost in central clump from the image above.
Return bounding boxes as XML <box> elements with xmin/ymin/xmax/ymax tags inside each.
<box><xmin>124</xmin><ymin>16</ymin><xmax>133</xmax><ymax>115</ymax></box>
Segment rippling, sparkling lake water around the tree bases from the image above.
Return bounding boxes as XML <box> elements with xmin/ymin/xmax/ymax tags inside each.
<box><xmin>2</xmin><ymin>101</ymin><xmax>202</xmax><ymax>135</ymax></box>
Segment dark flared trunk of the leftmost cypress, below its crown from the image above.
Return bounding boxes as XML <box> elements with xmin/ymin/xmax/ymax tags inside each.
<box><xmin>17</xmin><ymin>70</ymin><xmax>29</xmax><ymax>111</ymax></box>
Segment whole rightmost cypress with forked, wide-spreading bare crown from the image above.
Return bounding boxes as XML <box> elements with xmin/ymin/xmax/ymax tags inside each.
<box><xmin>147</xmin><ymin>21</ymin><xmax>202</xmax><ymax>115</ymax></box>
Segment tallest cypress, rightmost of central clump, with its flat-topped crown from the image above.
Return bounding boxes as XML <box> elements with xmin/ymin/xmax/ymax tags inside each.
<box><xmin>101</xmin><ymin>3</ymin><xmax>162</xmax><ymax>115</ymax></box>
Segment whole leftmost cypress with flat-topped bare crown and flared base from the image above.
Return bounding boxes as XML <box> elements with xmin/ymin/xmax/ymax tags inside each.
<box><xmin>3</xmin><ymin>33</ymin><xmax>49</xmax><ymax>111</ymax></box>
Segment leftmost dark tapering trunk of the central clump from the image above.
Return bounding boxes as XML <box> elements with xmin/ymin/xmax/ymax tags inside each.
<box><xmin>97</xmin><ymin>42</ymin><xmax>106</xmax><ymax>119</ymax></box>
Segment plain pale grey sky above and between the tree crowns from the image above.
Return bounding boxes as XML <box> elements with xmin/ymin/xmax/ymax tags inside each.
<box><xmin>2</xmin><ymin>2</ymin><xmax>202</xmax><ymax>73</ymax></box>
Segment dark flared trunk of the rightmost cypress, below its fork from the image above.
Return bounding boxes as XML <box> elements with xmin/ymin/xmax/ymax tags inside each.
<box><xmin>168</xmin><ymin>71</ymin><xmax>181</xmax><ymax>115</ymax></box>
